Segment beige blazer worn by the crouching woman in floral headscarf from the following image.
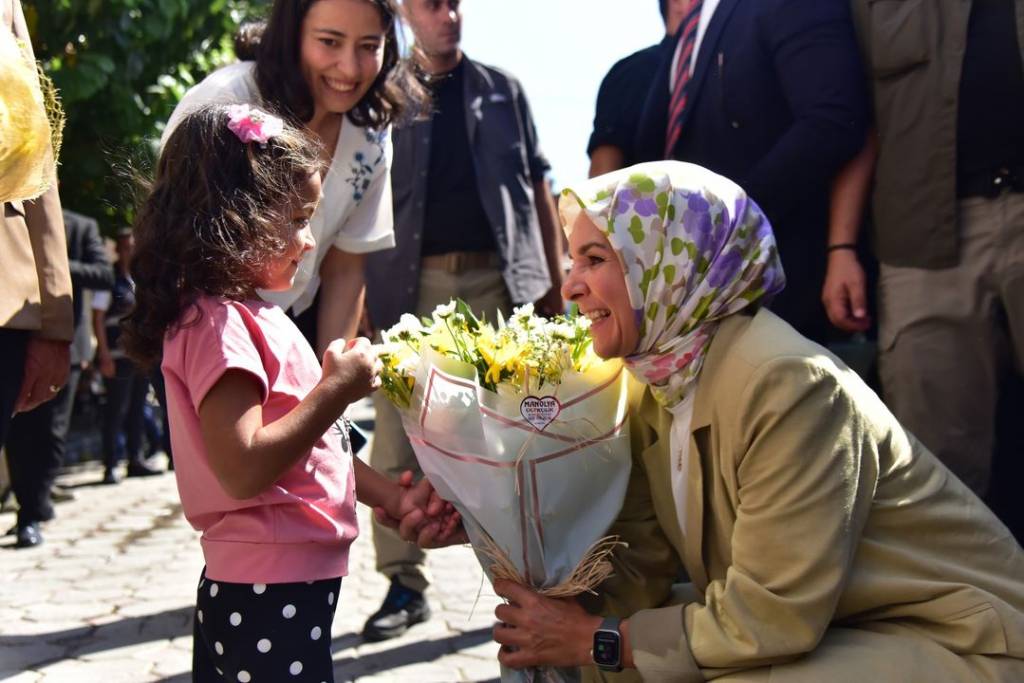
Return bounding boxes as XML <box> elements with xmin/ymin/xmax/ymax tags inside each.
<box><xmin>603</xmin><ymin>311</ymin><xmax>1024</xmax><ymax>683</ymax></box>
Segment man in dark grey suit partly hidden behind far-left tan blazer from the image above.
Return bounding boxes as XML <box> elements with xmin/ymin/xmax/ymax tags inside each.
<box><xmin>6</xmin><ymin>211</ymin><xmax>114</xmax><ymax>548</ymax></box>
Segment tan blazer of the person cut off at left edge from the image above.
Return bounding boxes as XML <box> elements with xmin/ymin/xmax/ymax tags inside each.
<box><xmin>0</xmin><ymin>0</ymin><xmax>74</xmax><ymax>341</ymax></box>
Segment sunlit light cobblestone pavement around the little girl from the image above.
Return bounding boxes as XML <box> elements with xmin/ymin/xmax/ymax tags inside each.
<box><xmin>0</xmin><ymin>409</ymin><xmax>498</xmax><ymax>683</ymax></box>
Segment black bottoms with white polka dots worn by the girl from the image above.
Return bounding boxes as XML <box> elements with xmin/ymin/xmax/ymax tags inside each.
<box><xmin>193</xmin><ymin>569</ymin><xmax>341</xmax><ymax>683</ymax></box>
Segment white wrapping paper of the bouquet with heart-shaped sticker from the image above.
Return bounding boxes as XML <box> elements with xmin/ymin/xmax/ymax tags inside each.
<box><xmin>401</xmin><ymin>349</ymin><xmax>632</xmax><ymax>683</ymax></box>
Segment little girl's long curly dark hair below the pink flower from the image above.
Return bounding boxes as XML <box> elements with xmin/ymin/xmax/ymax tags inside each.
<box><xmin>124</xmin><ymin>104</ymin><xmax>319</xmax><ymax>367</ymax></box>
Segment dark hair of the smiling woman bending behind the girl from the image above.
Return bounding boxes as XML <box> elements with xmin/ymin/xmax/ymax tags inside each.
<box><xmin>252</xmin><ymin>0</ymin><xmax>430</xmax><ymax>129</ymax></box>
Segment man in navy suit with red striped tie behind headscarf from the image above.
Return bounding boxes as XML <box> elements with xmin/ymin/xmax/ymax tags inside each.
<box><xmin>637</xmin><ymin>0</ymin><xmax>867</xmax><ymax>341</ymax></box>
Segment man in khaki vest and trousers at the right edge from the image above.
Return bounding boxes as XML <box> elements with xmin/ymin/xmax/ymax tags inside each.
<box><xmin>824</xmin><ymin>0</ymin><xmax>1024</xmax><ymax>537</ymax></box>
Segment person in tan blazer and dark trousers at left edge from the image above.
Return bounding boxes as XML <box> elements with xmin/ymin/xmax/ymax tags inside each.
<box><xmin>0</xmin><ymin>0</ymin><xmax>74</xmax><ymax>479</ymax></box>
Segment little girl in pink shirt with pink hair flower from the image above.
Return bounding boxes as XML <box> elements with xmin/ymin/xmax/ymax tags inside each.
<box><xmin>125</xmin><ymin>104</ymin><xmax>455</xmax><ymax>682</ymax></box>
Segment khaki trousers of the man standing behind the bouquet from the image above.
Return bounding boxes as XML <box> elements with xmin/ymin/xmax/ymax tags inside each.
<box><xmin>370</xmin><ymin>268</ymin><xmax>512</xmax><ymax>593</ymax></box>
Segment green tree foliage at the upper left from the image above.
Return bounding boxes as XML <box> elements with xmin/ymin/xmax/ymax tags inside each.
<box><xmin>23</xmin><ymin>0</ymin><xmax>263</xmax><ymax>234</ymax></box>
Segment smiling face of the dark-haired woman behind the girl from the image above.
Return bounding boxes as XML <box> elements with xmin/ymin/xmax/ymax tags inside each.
<box><xmin>300</xmin><ymin>0</ymin><xmax>385</xmax><ymax>114</ymax></box>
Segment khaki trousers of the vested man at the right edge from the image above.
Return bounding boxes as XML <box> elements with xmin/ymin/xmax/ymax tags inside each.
<box><xmin>879</xmin><ymin>193</ymin><xmax>1024</xmax><ymax>497</ymax></box>
